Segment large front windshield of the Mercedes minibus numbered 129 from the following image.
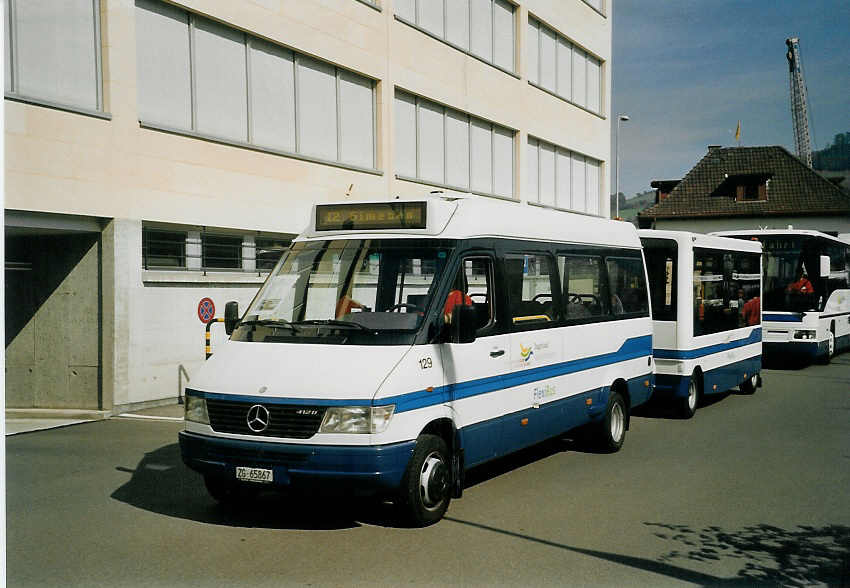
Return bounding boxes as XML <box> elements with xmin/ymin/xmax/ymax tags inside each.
<box><xmin>235</xmin><ymin>239</ymin><xmax>453</xmax><ymax>344</ymax></box>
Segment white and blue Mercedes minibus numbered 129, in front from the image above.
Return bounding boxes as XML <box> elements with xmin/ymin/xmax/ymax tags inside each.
<box><xmin>180</xmin><ymin>196</ymin><xmax>653</xmax><ymax>526</ymax></box>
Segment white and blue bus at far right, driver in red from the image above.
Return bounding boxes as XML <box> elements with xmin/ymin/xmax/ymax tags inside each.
<box><xmin>714</xmin><ymin>229</ymin><xmax>850</xmax><ymax>363</ymax></box>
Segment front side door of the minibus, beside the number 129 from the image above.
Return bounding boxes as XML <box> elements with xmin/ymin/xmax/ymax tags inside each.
<box><xmin>442</xmin><ymin>254</ymin><xmax>510</xmax><ymax>467</ymax></box>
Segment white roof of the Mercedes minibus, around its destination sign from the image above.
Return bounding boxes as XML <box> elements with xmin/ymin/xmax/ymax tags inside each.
<box><xmin>296</xmin><ymin>195</ymin><xmax>640</xmax><ymax>249</ymax></box>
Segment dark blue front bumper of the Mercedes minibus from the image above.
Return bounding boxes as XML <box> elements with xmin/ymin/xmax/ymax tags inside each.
<box><xmin>179</xmin><ymin>431</ymin><xmax>416</xmax><ymax>496</ymax></box>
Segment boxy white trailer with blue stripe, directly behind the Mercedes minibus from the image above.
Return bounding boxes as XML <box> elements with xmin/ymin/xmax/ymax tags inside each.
<box><xmin>638</xmin><ymin>230</ymin><xmax>762</xmax><ymax>418</ymax></box>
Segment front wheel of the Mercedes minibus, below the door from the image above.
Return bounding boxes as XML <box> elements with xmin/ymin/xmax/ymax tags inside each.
<box><xmin>397</xmin><ymin>435</ymin><xmax>451</xmax><ymax>527</ymax></box>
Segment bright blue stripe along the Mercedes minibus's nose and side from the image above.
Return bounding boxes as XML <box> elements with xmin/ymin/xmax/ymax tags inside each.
<box><xmin>186</xmin><ymin>335</ymin><xmax>652</xmax><ymax>413</ymax></box>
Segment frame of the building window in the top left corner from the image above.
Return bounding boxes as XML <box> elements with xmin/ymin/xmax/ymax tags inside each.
<box><xmin>3</xmin><ymin>0</ymin><xmax>112</xmax><ymax>120</ymax></box>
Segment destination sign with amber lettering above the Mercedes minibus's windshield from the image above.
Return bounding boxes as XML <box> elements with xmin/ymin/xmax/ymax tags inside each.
<box><xmin>316</xmin><ymin>201</ymin><xmax>428</xmax><ymax>231</ymax></box>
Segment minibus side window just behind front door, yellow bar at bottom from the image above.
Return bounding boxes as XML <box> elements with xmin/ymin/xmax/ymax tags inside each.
<box><xmin>505</xmin><ymin>254</ymin><xmax>559</xmax><ymax>326</ymax></box>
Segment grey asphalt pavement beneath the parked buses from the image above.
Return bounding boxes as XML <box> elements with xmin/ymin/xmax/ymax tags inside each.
<box><xmin>6</xmin><ymin>353</ymin><xmax>850</xmax><ymax>587</ymax></box>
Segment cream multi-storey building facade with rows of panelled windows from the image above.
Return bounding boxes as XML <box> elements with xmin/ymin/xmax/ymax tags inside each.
<box><xmin>4</xmin><ymin>0</ymin><xmax>611</xmax><ymax>412</ymax></box>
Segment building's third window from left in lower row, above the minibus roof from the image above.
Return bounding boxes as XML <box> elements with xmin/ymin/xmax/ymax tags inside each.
<box><xmin>395</xmin><ymin>91</ymin><xmax>515</xmax><ymax>198</ymax></box>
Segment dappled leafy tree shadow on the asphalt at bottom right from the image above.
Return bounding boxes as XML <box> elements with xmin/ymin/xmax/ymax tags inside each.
<box><xmin>645</xmin><ymin>523</ymin><xmax>850</xmax><ymax>586</ymax></box>
